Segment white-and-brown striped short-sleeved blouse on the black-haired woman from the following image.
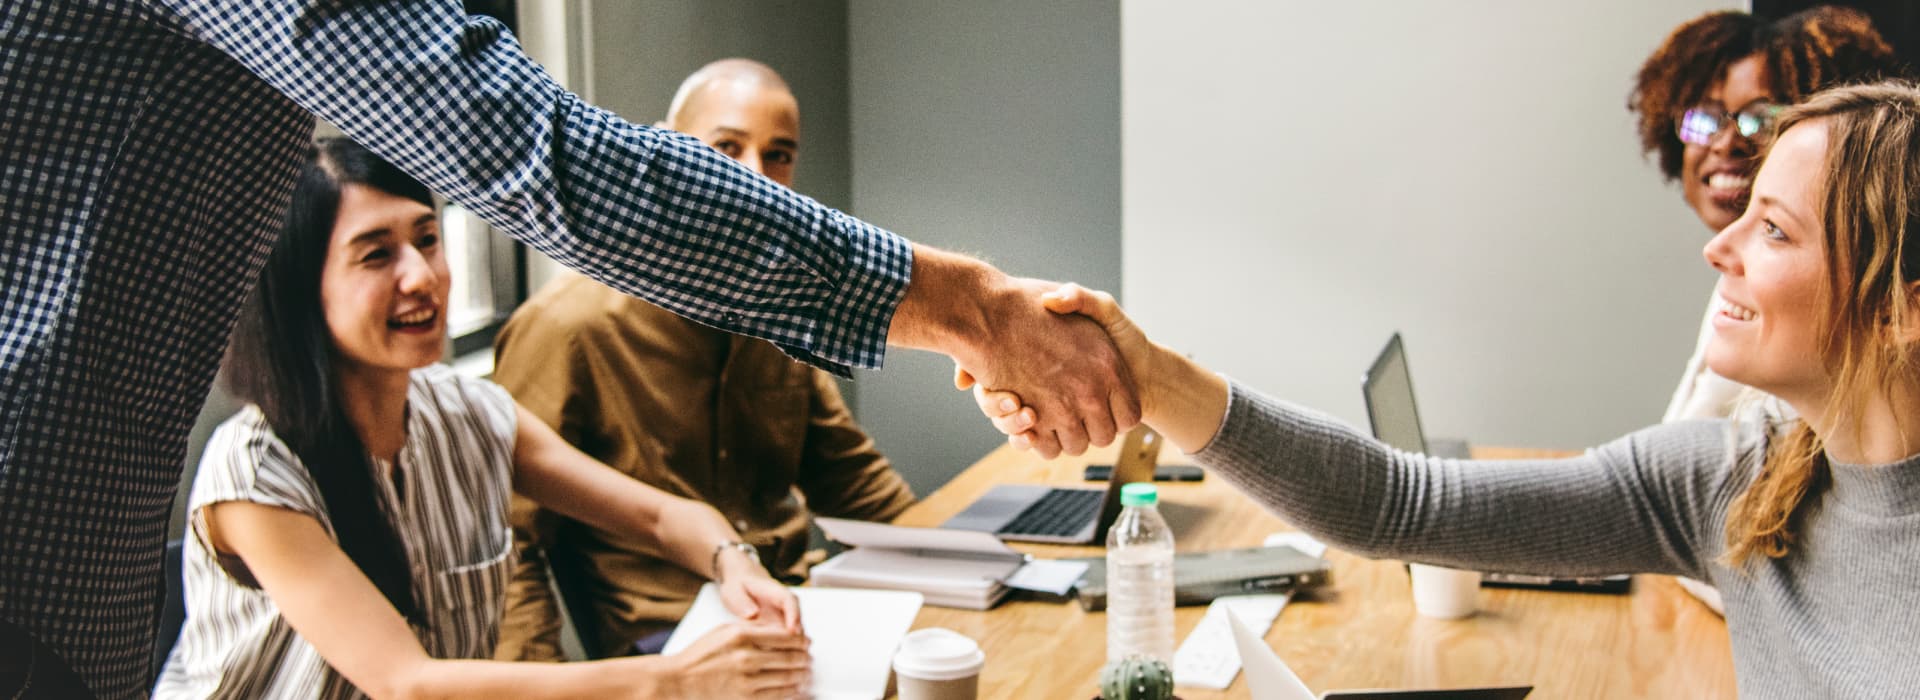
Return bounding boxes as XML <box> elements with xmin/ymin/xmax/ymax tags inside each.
<box><xmin>154</xmin><ymin>364</ymin><xmax>515</xmax><ymax>698</ymax></box>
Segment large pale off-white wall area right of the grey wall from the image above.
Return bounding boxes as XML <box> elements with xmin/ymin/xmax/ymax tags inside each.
<box><xmin>1121</xmin><ymin>0</ymin><xmax>1741</xmax><ymax>447</ymax></box>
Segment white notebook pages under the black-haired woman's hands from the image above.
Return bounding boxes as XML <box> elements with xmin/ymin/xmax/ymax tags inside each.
<box><xmin>662</xmin><ymin>583</ymin><xmax>922</xmax><ymax>700</ymax></box>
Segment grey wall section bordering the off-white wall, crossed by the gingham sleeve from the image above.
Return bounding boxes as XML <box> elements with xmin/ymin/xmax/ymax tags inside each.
<box><xmin>847</xmin><ymin>0</ymin><xmax>1121</xmax><ymax>495</ymax></box>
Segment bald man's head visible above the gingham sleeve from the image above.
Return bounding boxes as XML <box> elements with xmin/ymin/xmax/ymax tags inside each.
<box><xmin>660</xmin><ymin>58</ymin><xmax>801</xmax><ymax>188</ymax></box>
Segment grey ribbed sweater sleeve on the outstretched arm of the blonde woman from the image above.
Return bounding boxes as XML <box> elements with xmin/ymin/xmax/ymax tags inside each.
<box><xmin>1196</xmin><ymin>384</ymin><xmax>1743</xmax><ymax>577</ymax></box>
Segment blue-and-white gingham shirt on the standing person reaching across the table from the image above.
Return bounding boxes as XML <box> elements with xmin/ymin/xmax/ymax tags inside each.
<box><xmin>0</xmin><ymin>0</ymin><xmax>912</xmax><ymax>698</ymax></box>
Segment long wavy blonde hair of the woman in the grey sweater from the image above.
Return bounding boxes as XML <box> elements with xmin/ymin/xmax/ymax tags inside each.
<box><xmin>1724</xmin><ymin>81</ymin><xmax>1920</xmax><ymax>564</ymax></box>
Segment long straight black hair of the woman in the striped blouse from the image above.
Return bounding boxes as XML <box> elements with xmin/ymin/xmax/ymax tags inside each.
<box><xmin>225</xmin><ymin>138</ymin><xmax>434</xmax><ymax>623</ymax></box>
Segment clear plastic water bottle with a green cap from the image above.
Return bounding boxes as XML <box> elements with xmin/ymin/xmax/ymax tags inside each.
<box><xmin>1106</xmin><ymin>483</ymin><xmax>1173</xmax><ymax>667</ymax></box>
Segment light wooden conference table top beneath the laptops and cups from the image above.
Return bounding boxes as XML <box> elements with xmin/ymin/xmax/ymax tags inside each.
<box><xmin>895</xmin><ymin>443</ymin><xmax>1734</xmax><ymax>700</ymax></box>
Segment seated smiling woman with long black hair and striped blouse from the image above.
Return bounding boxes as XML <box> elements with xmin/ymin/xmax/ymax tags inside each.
<box><xmin>156</xmin><ymin>138</ymin><xmax>808</xmax><ymax>698</ymax></box>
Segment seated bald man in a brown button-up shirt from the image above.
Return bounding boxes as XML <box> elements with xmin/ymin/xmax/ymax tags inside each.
<box><xmin>493</xmin><ymin>59</ymin><xmax>914</xmax><ymax>660</ymax></box>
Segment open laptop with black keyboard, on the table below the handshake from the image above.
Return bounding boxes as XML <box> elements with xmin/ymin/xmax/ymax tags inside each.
<box><xmin>941</xmin><ymin>426</ymin><xmax>1160</xmax><ymax>545</ymax></box>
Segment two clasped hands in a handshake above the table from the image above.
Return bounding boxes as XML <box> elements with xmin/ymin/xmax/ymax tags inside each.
<box><xmin>891</xmin><ymin>247</ymin><xmax>1227</xmax><ymax>458</ymax></box>
